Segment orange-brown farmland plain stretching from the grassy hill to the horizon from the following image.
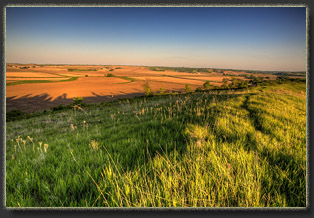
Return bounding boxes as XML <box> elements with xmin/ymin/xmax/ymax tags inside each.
<box><xmin>6</xmin><ymin>64</ymin><xmax>298</xmax><ymax>112</ymax></box>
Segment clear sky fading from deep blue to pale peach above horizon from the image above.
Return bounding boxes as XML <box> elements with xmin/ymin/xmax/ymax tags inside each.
<box><xmin>5</xmin><ymin>7</ymin><xmax>306</xmax><ymax>71</ymax></box>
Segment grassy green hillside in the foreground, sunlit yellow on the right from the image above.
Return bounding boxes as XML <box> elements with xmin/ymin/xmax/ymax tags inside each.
<box><xmin>6</xmin><ymin>82</ymin><xmax>306</xmax><ymax>207</ymax></box>
